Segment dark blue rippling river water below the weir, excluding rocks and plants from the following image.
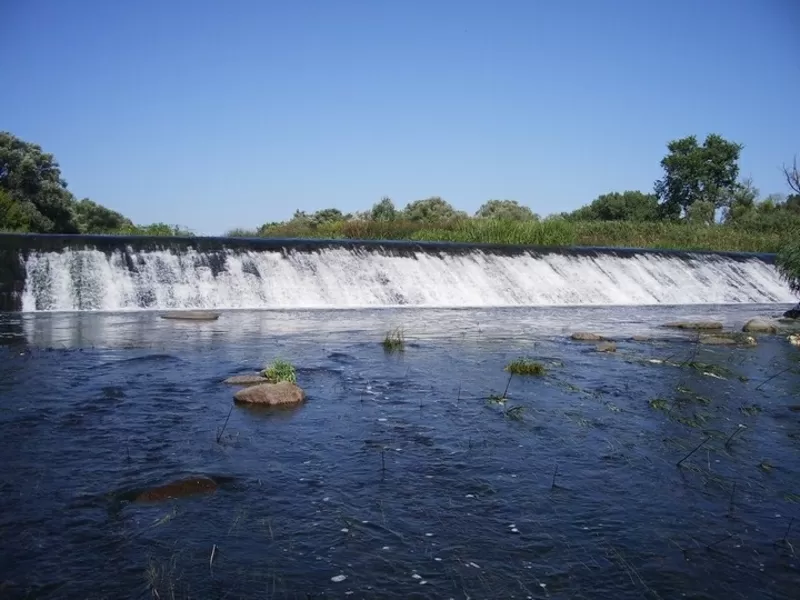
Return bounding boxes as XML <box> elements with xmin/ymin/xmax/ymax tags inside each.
<box><xmin>0</xmin><ymin>306</ymin><xmax>800</xmax><ymax>600</ymax></box>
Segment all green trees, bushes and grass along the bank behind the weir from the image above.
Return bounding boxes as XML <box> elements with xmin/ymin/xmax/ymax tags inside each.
<box><xmin>0</xmin><ymin>132</ymin><xmax>800</xmax><ymax>256</ymax></box>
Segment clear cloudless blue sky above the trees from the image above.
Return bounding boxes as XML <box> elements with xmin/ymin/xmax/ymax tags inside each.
<box><xmin>0</xmin><ymin>0</ymin><xmax>800</xmax><ymax>234</ymax></box>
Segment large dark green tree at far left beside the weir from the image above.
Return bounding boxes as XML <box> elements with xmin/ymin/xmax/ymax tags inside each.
<box><xmin>0</xmin><ymin>131</ymin><xmax>78</xmax><ymax>233</ymax></box>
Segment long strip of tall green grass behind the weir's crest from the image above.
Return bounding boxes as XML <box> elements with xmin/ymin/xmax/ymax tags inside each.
<box><xmin>252</xmin><ymin>219</ymin><xmax>800</xmax><ymax>252</ymax></box>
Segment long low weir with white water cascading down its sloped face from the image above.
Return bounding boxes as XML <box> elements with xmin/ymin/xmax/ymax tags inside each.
<box><xmin>0</xmin><ymin>234</ymin><xmax>794</xmax><ymax>312</ymax></box>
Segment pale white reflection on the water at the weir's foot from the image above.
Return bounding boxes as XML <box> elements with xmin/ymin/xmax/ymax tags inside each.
<box><xmin>0</xmin><ymin>304</ymin><xmax>788</xmax><ymax>348</ymax></box>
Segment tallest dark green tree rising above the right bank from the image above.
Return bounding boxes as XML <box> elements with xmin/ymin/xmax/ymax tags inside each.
<box><xmin>655</xmin><ymin>134</ymin><xmax>743</xmax><ymax>218</ymax></box>
